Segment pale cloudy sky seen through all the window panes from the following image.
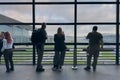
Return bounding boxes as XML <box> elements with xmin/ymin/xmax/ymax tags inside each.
<box><xmin>0</xmin><ymin>0</ymin><xmax>116</xmax><ymax>36</ymax></box>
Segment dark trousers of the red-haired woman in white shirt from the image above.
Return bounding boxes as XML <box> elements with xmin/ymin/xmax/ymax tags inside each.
<box><xmin>4</xmin><ymin>49</ymin><xmax>14</xmax><ymax>70</ymax></box>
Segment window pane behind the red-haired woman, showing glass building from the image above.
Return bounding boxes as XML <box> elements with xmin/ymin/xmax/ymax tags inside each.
<box><xmin>0</xmin><ymin>25</ymin><xmax>32</xmax><ymax>43</ymax></box>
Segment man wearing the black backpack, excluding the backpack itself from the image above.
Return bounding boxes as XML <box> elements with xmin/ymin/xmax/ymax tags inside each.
<box><xmin>36</xmin><ymin>23</ymin><xmax>47</xmax><ymax>72</ymax></box>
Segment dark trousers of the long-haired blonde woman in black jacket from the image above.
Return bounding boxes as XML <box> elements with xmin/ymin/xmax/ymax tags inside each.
<box><xmin>53</xmin><ymin>51</ymin><xmax>65</xmax><ymax>68</ymax></box>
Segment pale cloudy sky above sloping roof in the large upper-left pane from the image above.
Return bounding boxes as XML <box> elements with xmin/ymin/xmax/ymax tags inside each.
<box><xmin>0</xmin><ymin>5</ymin><xmax>32</xmax><ymax>22</ymax></box>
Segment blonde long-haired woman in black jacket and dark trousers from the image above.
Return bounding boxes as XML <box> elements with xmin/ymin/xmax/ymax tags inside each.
<box><xmin>52</xmin><ymin>27</ymin><xmax>66</xmax><ymax>71</ymax></box>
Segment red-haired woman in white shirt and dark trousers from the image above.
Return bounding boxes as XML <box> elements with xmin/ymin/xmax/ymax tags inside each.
<box><xmin>1</xmin><ymin>32</ymin><xmax>14</xmax><ymax>72</ymax></box>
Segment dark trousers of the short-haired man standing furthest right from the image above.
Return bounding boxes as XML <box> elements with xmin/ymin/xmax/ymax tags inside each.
<box><xmin>87</xmin><ymin>46</ymin><xmax>99</xmax><ymax>69</ymax></box>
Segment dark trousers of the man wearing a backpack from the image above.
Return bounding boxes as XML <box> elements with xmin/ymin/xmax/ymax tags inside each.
<box><xmin>36</xmin><ymin>44</ymin><xmax>44</xmax><ymax>69</ymax></box>
